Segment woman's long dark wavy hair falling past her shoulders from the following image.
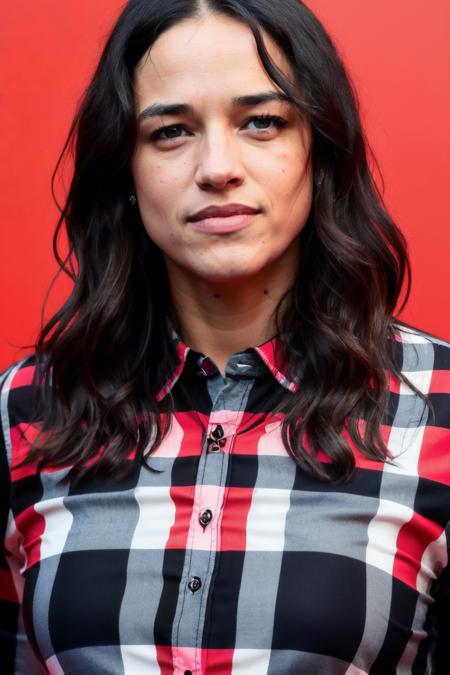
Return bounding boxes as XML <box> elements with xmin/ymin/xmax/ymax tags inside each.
<box><xmin>28</xmin><ymin>0</ymin><xmax>410</xmax><ymax>482</ymax></box>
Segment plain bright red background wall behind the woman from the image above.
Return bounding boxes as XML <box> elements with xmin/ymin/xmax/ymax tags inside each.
<box><xmin>0</xmin><ymin>0</ymin><xmax>450</xmax><ymax>369</ymax></box>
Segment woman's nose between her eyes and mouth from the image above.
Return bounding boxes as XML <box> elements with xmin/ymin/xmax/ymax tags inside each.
<box><xmin>195</xmin><ymin>127</ymin><xmax>244</xmax><ymax>191</ymax></box>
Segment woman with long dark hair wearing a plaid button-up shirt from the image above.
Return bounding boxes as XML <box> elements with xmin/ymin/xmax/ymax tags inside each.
<box><xmin>0</xmin><ymin>0</ymin><xmax>450</xmax><ymax>675</ymax></box>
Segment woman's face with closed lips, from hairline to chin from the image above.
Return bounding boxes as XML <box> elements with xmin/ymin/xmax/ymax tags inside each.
<box><xmin>132</xmin><ymin>15</ymin><xmax>312</xmax><ymax>284</ymax></box>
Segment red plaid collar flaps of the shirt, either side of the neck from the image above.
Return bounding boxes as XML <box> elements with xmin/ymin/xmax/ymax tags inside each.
<box><xmin>157</xmin><ymin>331</ymin><xmax>298</xmax><ymax>401</ymax></box>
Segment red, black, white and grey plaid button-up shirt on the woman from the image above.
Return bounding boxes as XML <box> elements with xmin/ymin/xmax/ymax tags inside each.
<box><xmin>0</xmin><ymin>329</ymin><xmax>450</xmax><ymax>675</ymax></box>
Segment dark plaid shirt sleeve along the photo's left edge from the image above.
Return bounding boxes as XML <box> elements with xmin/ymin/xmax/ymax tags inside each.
<box><xmin>0</xmin><ymin>366</ymin><xmax>44</xmax><ymax>675</ymax></box>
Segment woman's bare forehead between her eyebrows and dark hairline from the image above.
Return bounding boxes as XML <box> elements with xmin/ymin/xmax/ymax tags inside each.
<box><xmin>135</xmin><ymin>14</ymin><xmax>291</xmax><ymax>105</ymax></box>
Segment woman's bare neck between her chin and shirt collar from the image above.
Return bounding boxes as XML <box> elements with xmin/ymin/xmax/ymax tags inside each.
<box><xmin>168</xmin><ymin>264</ymin><xmax>293</xmax><ymax>373</ymax></box>
